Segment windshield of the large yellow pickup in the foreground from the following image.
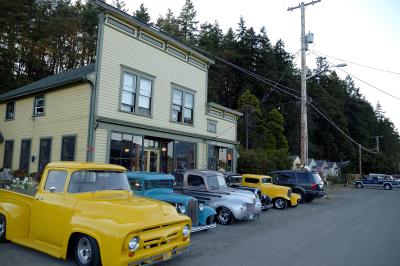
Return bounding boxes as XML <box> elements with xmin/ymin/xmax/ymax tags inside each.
<box><xmin>68</xmin><ymin>170</ymin><xmax>130</xmax><ymax>193</ymax></box>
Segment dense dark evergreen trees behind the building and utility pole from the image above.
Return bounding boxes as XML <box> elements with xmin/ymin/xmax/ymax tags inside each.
<box><xmin>0</xmin><ymin>0</ymin><xmax>400</xmax><ymax>173</ymax></box>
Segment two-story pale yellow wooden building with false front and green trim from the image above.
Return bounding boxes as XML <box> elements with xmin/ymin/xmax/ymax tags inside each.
<box><xmin>0</xmin><ymin>1</ymin><xmax>241</xmax><ymax>175</ymax></box>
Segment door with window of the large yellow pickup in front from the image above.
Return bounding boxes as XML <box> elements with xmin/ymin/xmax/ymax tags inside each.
<box><xmin>29</xmin><ymin>169</ymin><xmax>68</xmax><ymax>248</ymax></box>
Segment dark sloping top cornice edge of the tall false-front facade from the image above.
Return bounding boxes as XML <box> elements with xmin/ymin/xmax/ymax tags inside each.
<box><xmin>94</xmin><ymin>0</ymin><xmax>215</xmax><ymax>64</ymax></box>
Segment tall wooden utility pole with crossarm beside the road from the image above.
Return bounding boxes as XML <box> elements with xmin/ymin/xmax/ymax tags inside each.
<box><xmin>287</xmin><ymin>0</ymin><xmax>321</xmax><ymax>165</ymax></box>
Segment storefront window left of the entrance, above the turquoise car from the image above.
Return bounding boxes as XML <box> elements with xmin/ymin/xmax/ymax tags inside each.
<box><xmin>110</xmin><ymin>132</ymin><xmax>143</xmax><ymax>171</ymax></box>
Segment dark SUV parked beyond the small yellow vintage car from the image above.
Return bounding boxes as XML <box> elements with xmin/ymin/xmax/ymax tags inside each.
<box><xmin>269</xmin><ymin>170</ymin><xmax>326</xmax><ymax>202</ymax></box>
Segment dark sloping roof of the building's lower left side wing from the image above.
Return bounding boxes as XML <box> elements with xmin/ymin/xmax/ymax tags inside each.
<box><xmin>0</xmin><ymin>64</ymin><xmax>95</xmax><ymax>102</ymax></box>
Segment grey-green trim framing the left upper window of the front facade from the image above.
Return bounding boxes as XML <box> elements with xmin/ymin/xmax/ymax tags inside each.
<box><xmin>118</xmin><ymin>65</ymin><xmax>156</xmax><ymax>118</ymax></box>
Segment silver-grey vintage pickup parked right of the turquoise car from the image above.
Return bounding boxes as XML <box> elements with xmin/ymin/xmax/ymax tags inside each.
<box><xmin>179</xmin><ymin>170</ymin><xmax>261</xmax><ymax>225</ymax></box>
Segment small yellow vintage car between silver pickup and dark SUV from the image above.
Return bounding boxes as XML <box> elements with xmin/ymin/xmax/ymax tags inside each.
<box><xmin>242</xmin><ymin>174</ymin><xmax>301</xmax><ymax>210</ymax></box>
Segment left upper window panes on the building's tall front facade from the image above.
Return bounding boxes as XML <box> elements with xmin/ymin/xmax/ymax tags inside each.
<box><xmin>121</xmin><ymin>71</ymin><xmax>153</xmax><ymax>116</ymax></box>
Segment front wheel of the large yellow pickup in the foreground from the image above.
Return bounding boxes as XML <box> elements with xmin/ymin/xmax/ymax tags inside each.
<box><xmin>74</xmin><ymin>235</ymin><xmax>101</xmax><ymax>266</ymax></box>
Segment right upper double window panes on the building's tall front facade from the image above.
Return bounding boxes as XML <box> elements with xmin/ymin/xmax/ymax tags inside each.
<box><xmin>171</xmin><ymin>88</ymin><xmax>194</xmax><ymax>125</ymax></box>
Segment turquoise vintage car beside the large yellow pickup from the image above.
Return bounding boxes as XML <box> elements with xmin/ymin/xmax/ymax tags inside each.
<box><xmin>127</xmin><ymin>172</ymin><xmax>216</xmax><ymax>232</ymax></box>
